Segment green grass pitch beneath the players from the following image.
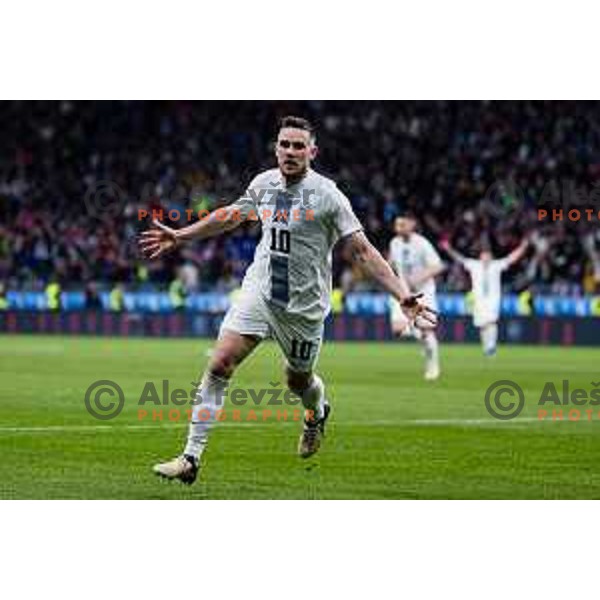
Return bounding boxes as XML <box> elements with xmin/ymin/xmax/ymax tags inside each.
<box><xmin>0</xmin><ymin>336</ymin><xmax>600</xmax><ymax>499</ymax></box>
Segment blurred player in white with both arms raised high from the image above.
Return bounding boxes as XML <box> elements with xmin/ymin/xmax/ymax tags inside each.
<box><xmin>440</xmin><ymin>239</ymin><xmax>528</xmax><ymax>356</ymax></box>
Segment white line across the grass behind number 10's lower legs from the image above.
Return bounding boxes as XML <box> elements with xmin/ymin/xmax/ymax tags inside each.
<box><xmin>0</xmin><ymin>417</ymin><xmax>589</xmax><ymax>434</ymax></box>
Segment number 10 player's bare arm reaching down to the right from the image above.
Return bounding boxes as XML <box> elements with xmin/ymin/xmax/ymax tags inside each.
<box><xmin>348</xmin><ymin>231</ymin><xmax>437</xmax><ymax>324</ymax></box>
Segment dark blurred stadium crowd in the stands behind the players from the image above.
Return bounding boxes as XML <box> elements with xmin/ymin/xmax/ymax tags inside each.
<box><xmin>0</xmin><ymin>101</ymin><xmax>600</xmax><ymax>302</ymax></box>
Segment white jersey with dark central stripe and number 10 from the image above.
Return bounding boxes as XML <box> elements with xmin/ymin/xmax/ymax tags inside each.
<box><xmin>232</xmin><ymin>169</ymin><xmax>362</xmax><ymax>320</ymax></box>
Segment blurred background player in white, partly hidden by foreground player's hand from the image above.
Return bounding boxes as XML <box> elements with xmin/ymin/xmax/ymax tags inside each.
<box><xmin>388</xmin><ymin>215</ymin><xmax>444</xmax><ymax>381</ymax></box>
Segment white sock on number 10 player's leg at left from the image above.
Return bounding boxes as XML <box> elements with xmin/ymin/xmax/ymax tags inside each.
<box><xmin>183</xmin><ymin>373</ymin><xmax>229</xmax><ymax>459</ymax></box>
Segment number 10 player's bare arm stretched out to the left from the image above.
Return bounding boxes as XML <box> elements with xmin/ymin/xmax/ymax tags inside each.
<box><xmin>139</xmin><ymin>206</ymin><xmax>242</xmax><ymax>259</ymax></box>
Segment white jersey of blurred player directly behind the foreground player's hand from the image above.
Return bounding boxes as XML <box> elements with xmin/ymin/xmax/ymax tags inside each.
<box><xmin>389</xmin><ymin>233</ymin><xmax>442</xmax><ymax>296</ymax></box>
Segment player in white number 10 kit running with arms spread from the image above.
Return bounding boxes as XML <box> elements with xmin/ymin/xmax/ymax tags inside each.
<box><xmin>140</xmin><ymin>117</ymin><xmax>436</xmax><ymax>483</ymax></box>
